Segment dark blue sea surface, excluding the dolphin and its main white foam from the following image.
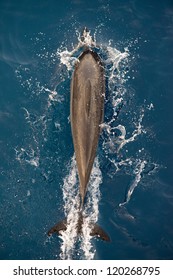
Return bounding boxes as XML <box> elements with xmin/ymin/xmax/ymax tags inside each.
<box><xmin>0</xmin><ymin>0</ymin><xmax>173</xmax><ymax>259</ymax></box>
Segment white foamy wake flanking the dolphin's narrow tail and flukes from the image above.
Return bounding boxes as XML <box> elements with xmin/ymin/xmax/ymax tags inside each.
<box><xmin>60</xmin><ymin>156</ymin><xmax>102</xmax><ymax>259</ymax></box>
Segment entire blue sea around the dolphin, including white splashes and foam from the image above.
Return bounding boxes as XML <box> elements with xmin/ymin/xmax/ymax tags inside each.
<box><xmin>0</xmin><ymin>0</ymin><xmax>173</xmax><ymax>260</ymax></box>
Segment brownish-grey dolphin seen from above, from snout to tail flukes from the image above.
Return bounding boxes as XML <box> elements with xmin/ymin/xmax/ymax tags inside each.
<box><xmin>48</xmin><ymin>28</ymin><xmax>110</xmax><ymax>241</ymax></box>
